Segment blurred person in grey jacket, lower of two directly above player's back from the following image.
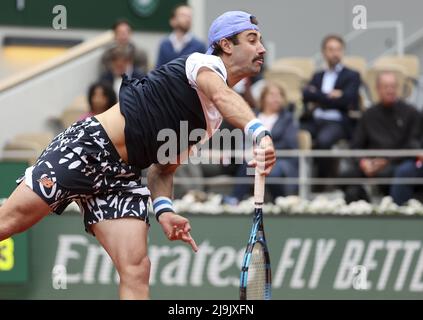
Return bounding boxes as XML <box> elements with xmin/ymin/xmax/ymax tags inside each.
<box><xmin>100</xmin><ymin>47</ymin><xmax>145</xmax><ymax>96</ymax></box>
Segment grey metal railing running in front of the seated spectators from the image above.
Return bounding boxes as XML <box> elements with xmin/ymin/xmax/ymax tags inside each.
<box><xmin>1</xmin><ymin>149</ymin><xmax>423</xmax><ymax>199</ymax></box>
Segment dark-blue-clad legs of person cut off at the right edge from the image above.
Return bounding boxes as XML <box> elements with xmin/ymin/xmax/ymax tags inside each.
<box><xmin>390</xmin><ymin>114</ymin><xmax>423</xmax><ymax>205</ymax></box>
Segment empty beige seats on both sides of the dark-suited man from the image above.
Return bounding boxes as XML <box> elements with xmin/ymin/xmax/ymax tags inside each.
<box><xmin>265</xmin><ymin>55</ymin><xmax>420</xmax><ymax>112</ymax></box>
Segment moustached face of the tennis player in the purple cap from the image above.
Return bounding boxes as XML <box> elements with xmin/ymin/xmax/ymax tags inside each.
<box><xmin>228</xmin><ymin>30</ymin><xmax>266</xmax><ymax>78</ymax></box>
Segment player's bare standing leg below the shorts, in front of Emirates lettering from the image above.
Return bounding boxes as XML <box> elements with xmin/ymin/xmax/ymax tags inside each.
<box><xmin>92</xmin><ymin>218</ymin><xmax>150</xmax><ymax>299</ymax></box>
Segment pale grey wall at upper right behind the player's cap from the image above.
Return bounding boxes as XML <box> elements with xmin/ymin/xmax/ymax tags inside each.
<box><xmin>204</xmin><ymin>0</ymin><xmax>423</xmax><ymax>65</ymax></box>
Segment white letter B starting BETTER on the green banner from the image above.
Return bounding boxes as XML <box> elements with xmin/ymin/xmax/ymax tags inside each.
<box><xmin>333</xmin><ymin>239</ymin><xmax>365</xmax><ymax>290</ymax></box>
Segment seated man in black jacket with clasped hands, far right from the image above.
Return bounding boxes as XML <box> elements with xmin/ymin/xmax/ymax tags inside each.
<box><xmin>340</xmin><ymin>71</ymin><xmax>420</xmax><ymax>203</ymax></box>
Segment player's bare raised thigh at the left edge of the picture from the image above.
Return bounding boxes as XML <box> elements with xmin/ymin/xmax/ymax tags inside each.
<box><xmin>0</xmin><ymin>182</ymin><xmax>51</xmax><ymax>241</ymax></box>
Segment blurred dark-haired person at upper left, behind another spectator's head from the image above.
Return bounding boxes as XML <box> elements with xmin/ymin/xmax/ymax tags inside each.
<box><xmin>100</xmin><ymin>20</ymin><xmax>148</xmax><ymax>73</ymax></box>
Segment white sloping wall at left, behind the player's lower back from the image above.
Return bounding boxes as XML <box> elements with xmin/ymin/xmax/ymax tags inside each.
<box><xmin>0</xmin><ymin>49</ymin><xmax>103</xmax><ymax>146</ymax></box>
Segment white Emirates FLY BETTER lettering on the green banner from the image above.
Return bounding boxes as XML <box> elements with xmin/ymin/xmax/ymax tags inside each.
<box><xmin>50</xmin><ymin>234</ymin><xmax>423</xmax><ymax>292</ymax></box>
